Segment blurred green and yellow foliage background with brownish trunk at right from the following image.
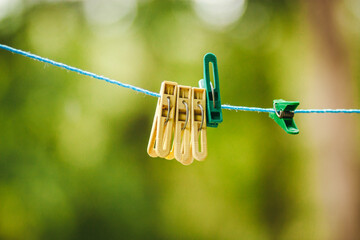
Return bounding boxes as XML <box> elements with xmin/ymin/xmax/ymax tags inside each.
<box><xmin>0</xmin><ymin>0</ymin><xmax>360</xmax><ymax>240</ymax></box>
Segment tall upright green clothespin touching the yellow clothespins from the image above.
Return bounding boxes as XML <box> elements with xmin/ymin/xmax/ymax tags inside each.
<box><xmin>199</xmin><ymin>53</ymin><xmax>223</xmax><ymax>127</ymax></box>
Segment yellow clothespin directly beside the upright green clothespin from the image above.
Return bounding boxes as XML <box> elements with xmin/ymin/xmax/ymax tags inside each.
<box><xmin>191</xmin><ymin>87</ymin><xmax>207</xmax><ymax>161</ymax></box>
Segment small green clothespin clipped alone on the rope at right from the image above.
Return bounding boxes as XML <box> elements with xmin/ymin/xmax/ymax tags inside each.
<box><xmin>269</xmin><ymin>99</ymin><xmax>300</xmax><ymax>134</ymax></box>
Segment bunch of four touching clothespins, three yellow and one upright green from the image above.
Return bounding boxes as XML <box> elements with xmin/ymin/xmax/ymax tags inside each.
<box><xmin>147</xmin><ymin>53</ymin><xmax>222</xmax><ymax>165</ymax></box>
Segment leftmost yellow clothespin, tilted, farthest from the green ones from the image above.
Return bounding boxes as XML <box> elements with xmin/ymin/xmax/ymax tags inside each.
<box><xmin>147</xmin><ymin>81</ymin><xmax>177</xmax><ymax>158</ymax></box>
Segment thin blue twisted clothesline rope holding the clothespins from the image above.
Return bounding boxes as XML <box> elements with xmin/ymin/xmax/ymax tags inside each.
<box><xmin>0</xmin><ymin>44</ymin><xmax>360</xmax><ymax>113</ymax></box>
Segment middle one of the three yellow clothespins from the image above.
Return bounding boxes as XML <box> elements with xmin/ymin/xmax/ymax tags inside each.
<box><xmin>173</xmin><ymin>86</ymin><xmax>193</xmax><ymax>165</ymax></box>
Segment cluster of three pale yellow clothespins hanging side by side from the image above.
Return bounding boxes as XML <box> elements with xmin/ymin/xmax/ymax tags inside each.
<box><xmin>147</xmin><ymin>81</ymin><xmax>207</xmax><ymax>165</ymax></box>
